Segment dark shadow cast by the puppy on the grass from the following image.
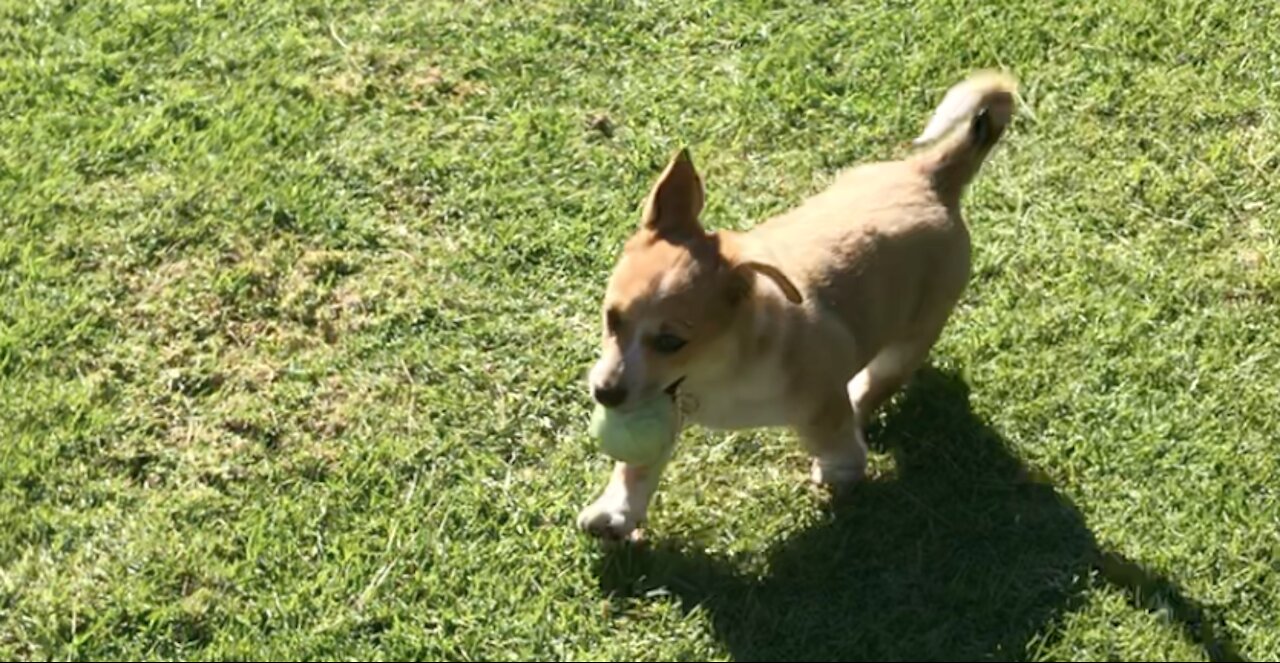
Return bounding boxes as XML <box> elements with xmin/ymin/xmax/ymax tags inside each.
<box><xmin>599</xmin><ymin>369</ymin><xmax>1243</xmax><ymax>660</ymax></box>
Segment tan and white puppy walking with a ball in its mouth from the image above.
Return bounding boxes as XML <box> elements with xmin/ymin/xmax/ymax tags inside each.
<box><xmin>579</xmin><ymin>73</ymin><xmax>1015</xmax><ymax>538</ymax></box>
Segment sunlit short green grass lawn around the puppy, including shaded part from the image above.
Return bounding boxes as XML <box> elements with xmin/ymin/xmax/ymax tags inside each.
<box><xmin>0</xmin><ymin>0</ymin><xmax>1280</xmax><ymax>660</ymax></box>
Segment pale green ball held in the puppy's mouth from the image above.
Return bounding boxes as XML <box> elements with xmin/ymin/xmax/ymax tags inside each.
<box><xmin>591</xmin><ymin>397</ymin><xmax>678</xmax><ymax>465</ymax></box>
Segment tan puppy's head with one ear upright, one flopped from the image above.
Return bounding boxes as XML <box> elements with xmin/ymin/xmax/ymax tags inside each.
<box><xmin>589</xmin><ymin>150</ymin><xmax>800</xmax><ymax>408</ymax></box>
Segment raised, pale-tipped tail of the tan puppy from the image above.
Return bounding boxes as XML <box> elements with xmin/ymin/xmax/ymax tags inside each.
<box><xmin>915</xmin><ymin>72</ymin><xmax>1018</xmax><ymax>195</ymax></box>
